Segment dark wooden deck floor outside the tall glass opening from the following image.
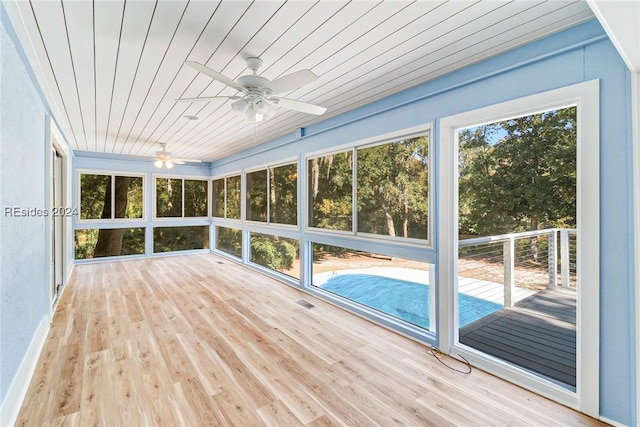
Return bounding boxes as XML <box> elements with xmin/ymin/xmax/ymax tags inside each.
<box><xmin>460</xmin><ymin>289</ymin><xmax>576</xmax><ymax>388</ymax></box>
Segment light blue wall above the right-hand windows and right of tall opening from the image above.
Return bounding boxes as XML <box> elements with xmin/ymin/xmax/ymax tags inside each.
<box><xmin>212</xmin><ymin>21</ymin><xmax>636</xmax><ymax>425</ymax></box>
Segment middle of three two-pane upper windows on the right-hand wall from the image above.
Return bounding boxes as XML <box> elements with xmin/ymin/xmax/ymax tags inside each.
<box><xmin>246</xmin><ymin>163</ymin><xmax>298</xmax><ymax>225</ymax></box>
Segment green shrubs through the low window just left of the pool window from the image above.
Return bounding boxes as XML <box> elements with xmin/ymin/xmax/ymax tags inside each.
<box><xmin>251</xmin><ymin>234</ymin><xmax>298</xmax><ymax>270</ymax></box>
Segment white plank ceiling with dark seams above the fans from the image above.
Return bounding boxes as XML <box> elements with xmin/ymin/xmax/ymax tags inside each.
<box><xmin>3</xmin><ymin>0</ymin><xmax>593</xmax><ymax>161</ymax></box>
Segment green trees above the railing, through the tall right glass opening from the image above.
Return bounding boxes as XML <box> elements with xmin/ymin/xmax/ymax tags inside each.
<box><xmin>459</xmin><ymin>107</ymin><xmax>576</xmax><ymax>236</ymax></box>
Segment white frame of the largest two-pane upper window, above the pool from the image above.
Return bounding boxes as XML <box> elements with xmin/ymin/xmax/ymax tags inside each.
<box><xmin>303</xmin><ymin>122</ymin><xmax>435</xmax><ymax>249</ymax></box>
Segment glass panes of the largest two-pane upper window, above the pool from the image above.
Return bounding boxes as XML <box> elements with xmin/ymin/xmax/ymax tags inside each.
<box><xmin>308</xmin><ymin>131</ymin><xmax>430</xmax><ymax>242</ymax></box>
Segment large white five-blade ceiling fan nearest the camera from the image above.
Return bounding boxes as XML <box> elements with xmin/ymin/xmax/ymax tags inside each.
<box><xmin>176</xmin><ymin>58</ymin><xmax>327</xmax><ymax>122</ymax></box>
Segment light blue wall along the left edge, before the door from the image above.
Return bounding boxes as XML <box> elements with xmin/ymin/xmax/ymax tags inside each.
<box><xmin>0</xmin><ymin>9</ymin><xmax>50</xmax><ymax>402</ymax></box>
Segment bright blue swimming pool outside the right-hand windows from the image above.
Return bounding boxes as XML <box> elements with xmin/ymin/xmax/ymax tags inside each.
<box><xmin>320</xmin><ymin>273</ymin><xmax>502</xmax><ymax>329</ymax></box>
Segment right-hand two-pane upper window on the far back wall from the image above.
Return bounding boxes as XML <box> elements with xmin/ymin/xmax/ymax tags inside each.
<box><xmin>156</xmin><ymin>178</ymin><xmax>209</xmax><ymax>218</ymax></box>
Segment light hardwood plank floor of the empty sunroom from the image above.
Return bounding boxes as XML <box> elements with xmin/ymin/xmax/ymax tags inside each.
<box><xmin>17</xmin><ymin>254</ymin><xmax>598</xmax><ymax>427</ymax></box>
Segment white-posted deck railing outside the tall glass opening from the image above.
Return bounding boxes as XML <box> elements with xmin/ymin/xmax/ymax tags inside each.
<box><xmin>458</xmin><ymin>228</ymin><xmax>577</xmax><ymax>307</ymax></box>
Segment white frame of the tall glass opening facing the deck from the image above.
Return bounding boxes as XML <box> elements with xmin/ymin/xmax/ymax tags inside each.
<box><xmin>437</xmin><ymin>80</ymin><xmax>600</xmax><ymax>418</ymax></box>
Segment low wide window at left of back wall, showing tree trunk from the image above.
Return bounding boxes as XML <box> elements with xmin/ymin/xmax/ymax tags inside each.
<box><xmin>74</xmin><ymin>228</ymin><xmax>144</xmax><ymax>259</ymax></box>
